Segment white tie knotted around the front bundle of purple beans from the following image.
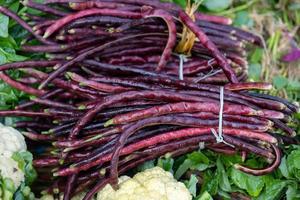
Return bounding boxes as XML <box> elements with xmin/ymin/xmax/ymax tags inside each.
<box><xmin>210</xmin><ymin>86</ymin><xmax>234</xmax><ymax>147</ymax></box>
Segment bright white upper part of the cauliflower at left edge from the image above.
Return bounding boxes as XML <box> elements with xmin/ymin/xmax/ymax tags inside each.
<box><xmin>0</xmin><ymin>123</ymin><xmax>27</xmax><ymax>158</ymax></box>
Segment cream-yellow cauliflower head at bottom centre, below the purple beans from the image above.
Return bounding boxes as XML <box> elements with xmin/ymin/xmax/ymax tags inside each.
<box><xmin>97</xmin><ymin>167</ymin><xmax>192</xmax><ymax>200</ymax></box>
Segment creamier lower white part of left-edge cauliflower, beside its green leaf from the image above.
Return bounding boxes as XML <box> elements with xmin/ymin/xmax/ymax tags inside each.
<box><xmin>0</xmin><ymin>155</ymin><xmax>25</xmax><ymax>188</ymax></box>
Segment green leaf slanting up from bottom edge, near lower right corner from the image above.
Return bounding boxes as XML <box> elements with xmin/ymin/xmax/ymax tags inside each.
<box><xmin>257</xmin><ymin>180</ymin><xmax>287</xmax><ymax>200</ymax></box>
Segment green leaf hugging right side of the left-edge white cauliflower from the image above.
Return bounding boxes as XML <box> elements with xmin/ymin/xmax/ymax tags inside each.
<box><xmin>12</xmin><ymin>151</ymin><xmax>37</xmax><ymax>185</ymax></box>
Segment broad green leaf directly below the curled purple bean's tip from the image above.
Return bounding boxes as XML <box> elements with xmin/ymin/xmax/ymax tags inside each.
<box><xmin>230</xmin><ymin>168</ymin><xmax>265</xmax><ymax>197</ymax></box>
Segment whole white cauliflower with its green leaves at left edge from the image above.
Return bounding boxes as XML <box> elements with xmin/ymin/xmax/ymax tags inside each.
<box><xmin>0</xmin><ymin>123</ymin><xmax>36</xmax><ymax>200</ymax></box>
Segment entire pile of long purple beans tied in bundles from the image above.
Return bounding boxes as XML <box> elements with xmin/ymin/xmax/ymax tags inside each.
<box><xmin>0</xmin><ymin>0</ymin><xmax>298</xmax><ymax>200</ymax></box>
